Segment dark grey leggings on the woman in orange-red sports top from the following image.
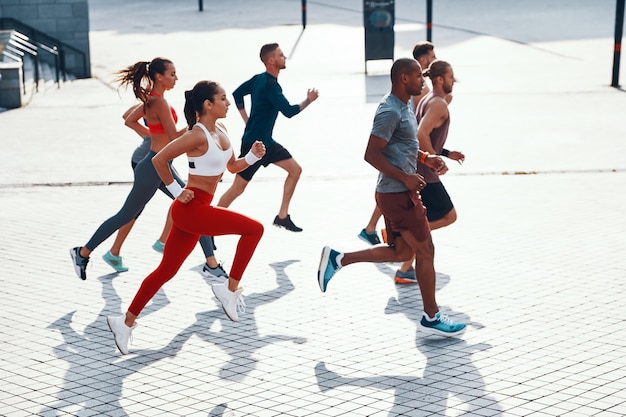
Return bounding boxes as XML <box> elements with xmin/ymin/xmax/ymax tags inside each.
<box><xmin>85</xmin><ymin>151</ymin><xmax>213</xmax><ymax>257</ymax></box>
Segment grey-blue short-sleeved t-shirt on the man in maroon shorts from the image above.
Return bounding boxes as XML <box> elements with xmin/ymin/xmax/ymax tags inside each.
<box><xmin>371</xmin><ymin>93</ymin><xmax>419</xmax><ymax>193</ymax></box>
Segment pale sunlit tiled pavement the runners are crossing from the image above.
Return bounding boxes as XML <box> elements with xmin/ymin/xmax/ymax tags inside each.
<box><xmin>0</xmin><ymin>0</ymin><xmax>626</xmax><ymax>417</ymax></box>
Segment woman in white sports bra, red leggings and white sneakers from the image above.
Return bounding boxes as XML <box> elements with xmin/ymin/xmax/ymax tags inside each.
<box><xmin>107</xmin><ymin>81</ymin><xmax>265</xmax><ymax>354</ymax></box>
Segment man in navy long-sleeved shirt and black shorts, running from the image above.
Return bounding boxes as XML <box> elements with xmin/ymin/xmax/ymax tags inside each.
<box><xmin>217</xmin><ymin>43</ymin><xmax>318</xmax><ymax>232</ymax></box>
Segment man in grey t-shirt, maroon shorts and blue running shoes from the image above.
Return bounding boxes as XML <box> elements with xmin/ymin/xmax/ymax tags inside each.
<box><xmin>317</xmin><ymin>58</ymin><xmax>465</xmax><ymax>336</ymax></box>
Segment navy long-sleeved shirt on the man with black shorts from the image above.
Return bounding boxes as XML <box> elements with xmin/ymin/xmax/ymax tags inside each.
<box><xmin>233</xmin><ymin>72</ymin><xmax>300</xmax><ymax>147</ymax></box>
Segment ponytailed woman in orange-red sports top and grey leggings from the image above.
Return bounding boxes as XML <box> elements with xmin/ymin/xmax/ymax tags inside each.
<box><xmin>70</xmin><ymin>58</ymin><xmax>213</xmax><ymax>280</ymax></box>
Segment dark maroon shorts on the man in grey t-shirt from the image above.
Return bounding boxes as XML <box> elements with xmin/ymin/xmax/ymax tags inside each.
<box><xmin>376</xmin><ymin>191</ymin><xmax>430</xmax><ymax>245</ymax></box>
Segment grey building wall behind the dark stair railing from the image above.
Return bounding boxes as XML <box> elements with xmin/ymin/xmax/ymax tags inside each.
<box><xmin>0</xmin><ymin>0</ymin><xmax>91</xmax><ymax>78</ymax></box>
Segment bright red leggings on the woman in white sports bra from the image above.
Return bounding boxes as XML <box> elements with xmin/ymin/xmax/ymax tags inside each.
<box><xmin>128</xmin><ymin>188</ymin><xmax>263</xmax><ymax>316</ymax></box>
